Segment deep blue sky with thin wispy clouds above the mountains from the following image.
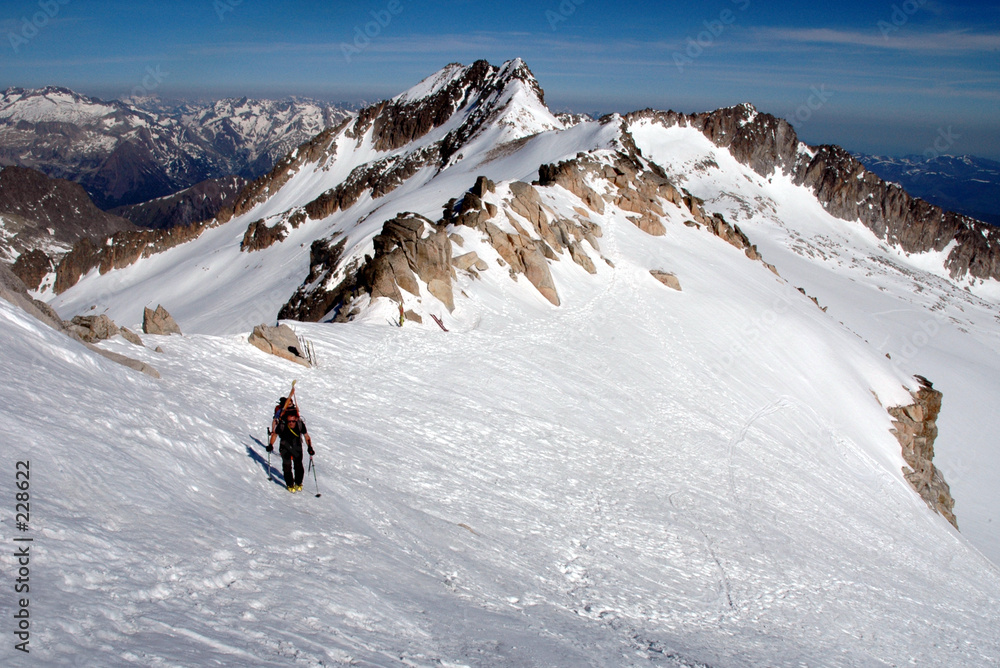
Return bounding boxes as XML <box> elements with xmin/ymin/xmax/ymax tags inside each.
<box><xmin>0</xmin><ymin>0</ymin><xmax>1000</xmax><ymax>159</ymax></box>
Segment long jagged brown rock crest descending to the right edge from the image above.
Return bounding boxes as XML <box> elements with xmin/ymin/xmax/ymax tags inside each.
<box><xmin>626</xmin><ymin>104</ymin><xmax>1000</xmax><ymax>280</ymax></box>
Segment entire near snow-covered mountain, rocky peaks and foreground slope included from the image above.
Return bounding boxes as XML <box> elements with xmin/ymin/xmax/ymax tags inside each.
<box><xmin>0</xmin><ymin>60</ymin><xmax>1000</xmax><ymax>666</ymax></box>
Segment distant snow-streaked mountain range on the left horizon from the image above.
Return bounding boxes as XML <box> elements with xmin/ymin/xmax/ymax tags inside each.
<box><xmin>0</xmin><ymin>86</ymin><xmax>346</xmax><ymax>209</ymax></box>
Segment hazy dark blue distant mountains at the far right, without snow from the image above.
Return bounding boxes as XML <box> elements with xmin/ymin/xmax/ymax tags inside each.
<box><xmin>854</xmin><ymin>153</ymin><xmax>1000</xmax><ymax>225</ymax></box>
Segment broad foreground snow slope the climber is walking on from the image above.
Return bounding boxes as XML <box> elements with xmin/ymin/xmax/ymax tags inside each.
<box><xmin>0</xmin><ymin>204</ymin><xmax>1000</xmax><ymax>666</ymax></box>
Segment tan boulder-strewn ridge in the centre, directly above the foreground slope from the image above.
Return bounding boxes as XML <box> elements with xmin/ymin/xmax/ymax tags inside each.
<box><xmin>278</xmin><ymin>142</ymin><xmax>777</xmax><ymax>321</ymax></box>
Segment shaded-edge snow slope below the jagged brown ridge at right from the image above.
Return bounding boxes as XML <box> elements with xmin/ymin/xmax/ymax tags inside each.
<box><xmin>631</xmin><ymin>117</ymin><xmax>1000</xmax><ymax>563</ymax></box>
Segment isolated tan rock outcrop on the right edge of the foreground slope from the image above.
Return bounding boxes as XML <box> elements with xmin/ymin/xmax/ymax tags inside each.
<box><xmin>888</xmin><ymin>376</ymin><xmax>958</xmax><ymax>529</ymax></box>
